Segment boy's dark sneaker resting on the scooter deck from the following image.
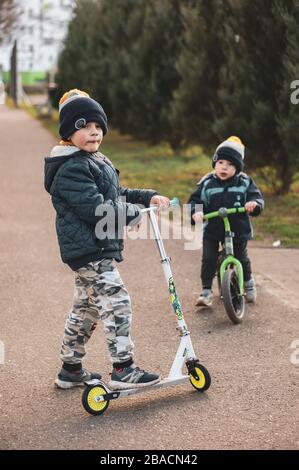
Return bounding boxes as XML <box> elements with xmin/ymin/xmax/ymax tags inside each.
<box><xmin>108</xmin><ymin>364</ymin><xmax>160</xmax><ymax>390</ymax></box>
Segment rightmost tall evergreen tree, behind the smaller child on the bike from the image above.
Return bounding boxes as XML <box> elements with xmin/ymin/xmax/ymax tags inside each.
<box><xmin>213</xmin><ymin>0</ymin><xmax>298</xmax><ymax>193</ymax></box>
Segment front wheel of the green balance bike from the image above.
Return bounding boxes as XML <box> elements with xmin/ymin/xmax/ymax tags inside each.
<box><xmin>221</xmin><ymin>268</ymin><xmax>245</xmax><ymax>324</ymax></box>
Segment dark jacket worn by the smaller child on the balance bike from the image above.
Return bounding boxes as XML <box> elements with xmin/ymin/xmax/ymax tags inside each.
<box><xmin>188</xmin><ymin>173</ymin><xmax>264</xmax><ymax>242</ymax></box>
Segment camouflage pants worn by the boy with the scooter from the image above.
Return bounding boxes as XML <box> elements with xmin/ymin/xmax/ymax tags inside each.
<box><xmin>60</xmin><ymin>259</ymin><xmax>134</xmax><ymax>364</ymax></box>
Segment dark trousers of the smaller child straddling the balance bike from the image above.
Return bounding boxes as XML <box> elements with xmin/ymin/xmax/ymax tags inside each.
<box><xmin>201</xmin><ymin>237</ymin><xmax>251</xmax><ymax>289</ymax></box>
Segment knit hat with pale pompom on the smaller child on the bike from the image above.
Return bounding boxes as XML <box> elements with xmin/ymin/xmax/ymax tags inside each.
<box><xmin>212</xmin><ymin>136</ymin><xmax>245</xmax><ymax>173</ymax></box>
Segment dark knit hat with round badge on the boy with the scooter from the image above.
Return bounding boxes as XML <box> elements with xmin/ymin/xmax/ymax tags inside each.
<box><xmin>59</xmin><ymin>94</ymin><xmax>108</xmax><ymax>140</ymax></box>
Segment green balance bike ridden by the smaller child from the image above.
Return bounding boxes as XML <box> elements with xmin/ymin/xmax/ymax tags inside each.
<box><xmin>203</xmin><ymin>207</ymin><xmax>246</xmax><ymax>324</ymax></box>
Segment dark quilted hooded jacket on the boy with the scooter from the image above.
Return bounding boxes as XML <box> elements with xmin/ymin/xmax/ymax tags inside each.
<box><xmin>45</xmin><ymin>146</ymin><xmax>157</xmax><ymax>270</ymax></box>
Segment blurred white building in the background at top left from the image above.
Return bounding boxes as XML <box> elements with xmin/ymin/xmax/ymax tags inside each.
<box><xmin>0</xmin><ymin>0</ymin><xmax>75</xmax><ymax>72</ymax></box>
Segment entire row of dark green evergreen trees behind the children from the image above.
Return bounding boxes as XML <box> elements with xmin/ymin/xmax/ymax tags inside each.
<box><xmin>57</xmin><ymin>0</ymin><xmax>299</xmax><ymax>194</ymax></box>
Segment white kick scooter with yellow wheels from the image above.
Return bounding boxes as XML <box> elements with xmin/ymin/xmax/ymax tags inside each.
<box><xmin>82</xmin><ymin>198</ymin><xmax>211</xmax><ymax>415</ymax></box>
